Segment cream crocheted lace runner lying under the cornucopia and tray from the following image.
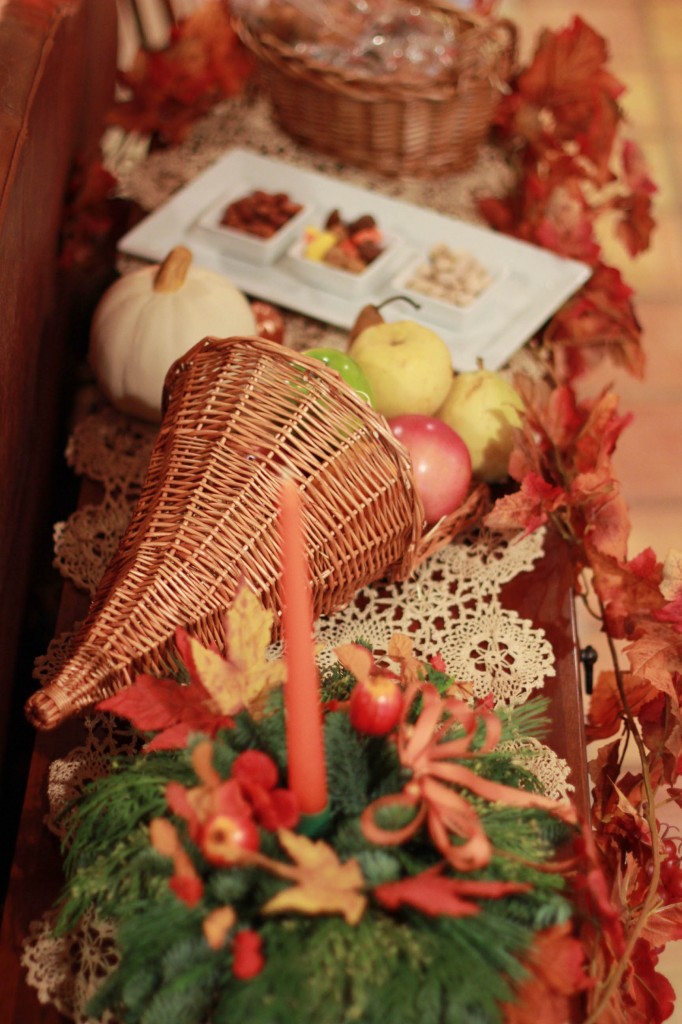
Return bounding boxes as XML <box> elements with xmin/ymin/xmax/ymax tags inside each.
<box><xmin>23</xmin><ymin>94</ymin><xmax>572</xmax><ymax>1022</ymax></box>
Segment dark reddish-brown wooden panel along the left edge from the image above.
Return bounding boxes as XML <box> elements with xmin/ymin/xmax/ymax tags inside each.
<box><xmin>0</xmin><ymin>0</ymin><xmax>117</xmax><ymax>781</ymax></box>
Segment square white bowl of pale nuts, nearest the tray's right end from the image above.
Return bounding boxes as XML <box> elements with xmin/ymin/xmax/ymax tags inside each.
<box><xmin>391</xmin><ymin>243</ymin><xmax>504</xmax><ymax>328</ymax></box>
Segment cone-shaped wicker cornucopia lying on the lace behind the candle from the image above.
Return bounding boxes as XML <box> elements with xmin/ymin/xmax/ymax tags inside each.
<box><xmin>26</xmin><ymin>338</ymin><xmax>486</xmax><ymax>728</ymax></box>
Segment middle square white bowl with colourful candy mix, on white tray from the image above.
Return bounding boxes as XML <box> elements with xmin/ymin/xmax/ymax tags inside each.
<box><xmin>288</xmin><ymin>210</ymin><xmax>400</xmax><ymax>298</ymax></box>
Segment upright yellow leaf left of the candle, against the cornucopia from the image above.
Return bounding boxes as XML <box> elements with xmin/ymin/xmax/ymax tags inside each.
<box><xmin>184</xmin><ymin>583</ymin><xmax>285</xmax><ymax>715</ymax></box>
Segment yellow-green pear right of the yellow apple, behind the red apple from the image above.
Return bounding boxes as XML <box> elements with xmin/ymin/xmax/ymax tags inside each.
<box><xmin>436</xmin><ymin>370</ymin><xmax>523</xmax><ymax>483</ymax></box>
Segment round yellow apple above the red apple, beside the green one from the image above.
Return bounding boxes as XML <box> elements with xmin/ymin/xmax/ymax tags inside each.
<box><xmin>348</xmin><ymin>321</ymin><xmax>453</xmax><ymax>419</ymax></box>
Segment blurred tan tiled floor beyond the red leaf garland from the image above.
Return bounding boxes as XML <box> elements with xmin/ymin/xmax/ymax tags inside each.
<box><xmin>502</xmin><ymin>0</ymin><xmax>682</xmax><ymax>1011</ymax></box>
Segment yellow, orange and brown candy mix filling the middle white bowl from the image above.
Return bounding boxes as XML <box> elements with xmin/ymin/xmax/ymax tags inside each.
<box><xmin>303</xmin><ymin>210</ymin><xmax>385</xmax><ymax>273</ymax></box>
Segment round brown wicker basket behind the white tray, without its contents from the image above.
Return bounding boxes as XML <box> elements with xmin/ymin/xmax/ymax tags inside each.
<box><xmin>235</xmin><ymin>0</ymin><xmax>516</xmax><ymax>177</ymax></box>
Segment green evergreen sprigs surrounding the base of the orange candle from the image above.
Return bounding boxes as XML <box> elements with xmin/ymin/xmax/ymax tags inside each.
<box><xmin>59</xmin><ymin>694</ymin><xmax>568</xmax><ymax>1024</ymax></box>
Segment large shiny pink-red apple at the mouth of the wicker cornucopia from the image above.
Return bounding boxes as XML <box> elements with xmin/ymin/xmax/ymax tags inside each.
<box><xmin>388</xmin><ymin>415</ymin><xmax>471</xmax><ymax>525</ymax></box>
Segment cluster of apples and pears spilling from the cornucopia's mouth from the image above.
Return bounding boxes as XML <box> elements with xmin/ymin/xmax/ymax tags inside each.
<box><xmin>308</xmin><ymin>296</ymin><xmax>523</xmax><ymax>525</ymax></box>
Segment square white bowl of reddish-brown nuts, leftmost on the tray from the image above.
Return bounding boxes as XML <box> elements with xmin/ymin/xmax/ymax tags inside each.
<box><xmin>193</xmin><ymin>186</ymin><xmax>309</xmax><ymax>266</ymax></box>
